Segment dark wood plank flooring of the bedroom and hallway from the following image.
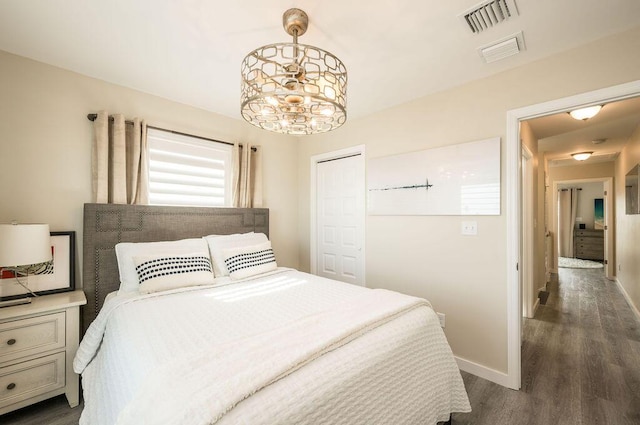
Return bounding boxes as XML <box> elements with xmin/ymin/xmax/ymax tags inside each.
<box><xmin>0</xmin><ymin>269</ymin><xmax>640</xmax><ymax>425</ymax></box>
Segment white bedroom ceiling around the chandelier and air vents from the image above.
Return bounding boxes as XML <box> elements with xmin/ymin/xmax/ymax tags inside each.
<box><xmin>0</xmin><ymin>0</ymin><xmax>640</xmax><ymax>123</ymax></box>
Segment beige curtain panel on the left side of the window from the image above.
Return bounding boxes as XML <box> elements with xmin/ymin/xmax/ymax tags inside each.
<box><xmin>92</xmin><ymin>111</ymin><xmax>149</xmax><ymax>204</ymax></box>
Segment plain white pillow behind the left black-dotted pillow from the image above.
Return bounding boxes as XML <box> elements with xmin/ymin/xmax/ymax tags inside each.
<box><xmin>116</xmin><ymin>238</ymin><xmax>209</xmax><ymax>293</ymax></box>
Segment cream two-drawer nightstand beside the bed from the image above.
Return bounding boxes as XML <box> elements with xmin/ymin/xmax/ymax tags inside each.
<box><xmin>0</xmin><ymin>290</ymin><xmax>87</xmax><ymax>415</ymax></box>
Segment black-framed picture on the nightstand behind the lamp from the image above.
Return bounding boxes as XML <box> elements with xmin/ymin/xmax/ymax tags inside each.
<box><xmin>0</xmin><ymin>231</ymin><xmax>76</xmax><ymax>301</ymax></box>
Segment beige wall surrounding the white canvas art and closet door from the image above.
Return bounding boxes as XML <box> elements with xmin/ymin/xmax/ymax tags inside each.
<box><xmin>298</xmin><ymin>26</ymin><xmax>640</xmax><ymax>373</ymax></box>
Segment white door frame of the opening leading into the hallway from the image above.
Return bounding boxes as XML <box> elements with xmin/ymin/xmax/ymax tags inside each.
<box><xmin>505</xmin><ymin>80</ymin><xmax>640</xmax><ymax>390</ymax></box>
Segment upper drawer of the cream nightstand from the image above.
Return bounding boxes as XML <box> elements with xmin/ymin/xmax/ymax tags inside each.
<box><xmin>0</xmin><ymin>311</ymin><xmax>65</xmax><ymax>363</ymax></box>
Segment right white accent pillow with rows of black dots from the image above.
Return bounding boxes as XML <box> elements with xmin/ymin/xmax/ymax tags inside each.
<box><xmin>222</xmin><ymin>242</ymin><xmax>278</xmax><ymax>280</ymax></box>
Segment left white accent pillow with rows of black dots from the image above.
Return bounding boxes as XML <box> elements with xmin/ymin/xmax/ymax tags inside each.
<box><xmin>133</xmin><ymin>253</ymin><xmax>213</xmax><ymax>294</ymax></box>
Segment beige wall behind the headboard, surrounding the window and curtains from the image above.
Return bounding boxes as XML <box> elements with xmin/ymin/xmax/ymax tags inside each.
<box><xmin>0</xmin><ymin>51</ymin><xmax>298</xmax><ymax>285</ymax></box>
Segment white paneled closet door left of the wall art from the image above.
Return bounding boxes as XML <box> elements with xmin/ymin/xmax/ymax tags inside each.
<box><xmin>311</xmin><ymin>146</ymin><xmax>366</xmax><ymax>286</ymax></box>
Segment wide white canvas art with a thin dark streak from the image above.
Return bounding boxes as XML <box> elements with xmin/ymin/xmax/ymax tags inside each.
<box><xmin>367</xmin><ymin>137</ymin><xmax>500</xmax><ymax>215</ymax></box>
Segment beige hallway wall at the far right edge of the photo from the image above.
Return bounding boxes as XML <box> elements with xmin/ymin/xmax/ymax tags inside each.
<box><xmin>615</xmin><ymin>122</ymin><xmax>640</xmax><ymax>313</ymax></box>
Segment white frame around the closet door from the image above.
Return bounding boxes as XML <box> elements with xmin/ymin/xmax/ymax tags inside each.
<box><xmin>309</xmin><ymin>145</ymin><xmax>367</xmax><ymax>280</ymax></box>
